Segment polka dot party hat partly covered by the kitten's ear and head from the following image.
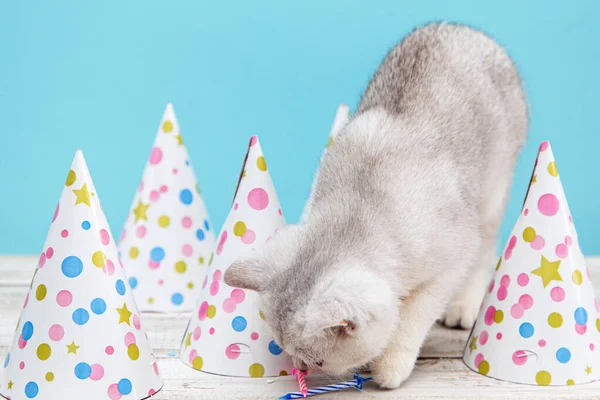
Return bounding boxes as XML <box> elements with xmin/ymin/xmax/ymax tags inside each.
<box><xmin>180</xmin><ymin>136</ymin><xmax>293</xmax><ymax>377</ymax></box>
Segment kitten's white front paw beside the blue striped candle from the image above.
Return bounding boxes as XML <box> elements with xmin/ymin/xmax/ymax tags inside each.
<box><xmin>372</xmin><ymin>352</ymin><xmax>417</xmax><ymax>389</ymax></box>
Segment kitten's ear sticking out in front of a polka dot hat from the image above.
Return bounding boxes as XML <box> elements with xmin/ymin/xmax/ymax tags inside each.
<box><xmin>224</xmin><ymin>255</ymin><xmax>268</xmax><ymax>292</ymax></box>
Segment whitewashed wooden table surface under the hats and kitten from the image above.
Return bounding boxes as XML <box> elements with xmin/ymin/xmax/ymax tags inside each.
<box><xmin>0</xmin><ymin>256</ymin><xmax>600</xmax><ymax>400</ymax></box>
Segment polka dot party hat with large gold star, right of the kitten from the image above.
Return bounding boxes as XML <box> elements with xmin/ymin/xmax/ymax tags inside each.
<box><xmin>463</xmin><ymin>142</ymin><xmax>600</xmax><ymax>386</ymax></box>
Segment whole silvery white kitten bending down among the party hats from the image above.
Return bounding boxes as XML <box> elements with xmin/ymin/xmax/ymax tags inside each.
<box><xmin>225</xmin><ymin>24</ymin><xmax>528</xmax><ymax>388</ymax></box>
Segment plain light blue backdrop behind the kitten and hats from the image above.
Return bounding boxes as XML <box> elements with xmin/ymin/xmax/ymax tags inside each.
<box><xmin>0</xmin><ymin>0</ymin><xmax>600</xmax><ymax>255</ymax></box>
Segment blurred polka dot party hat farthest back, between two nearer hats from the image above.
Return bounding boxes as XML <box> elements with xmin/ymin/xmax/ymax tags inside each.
<box><xmin>119</xmin><ymin>104</ymin><xmax>215</xmax><ymax>312</ymax></box>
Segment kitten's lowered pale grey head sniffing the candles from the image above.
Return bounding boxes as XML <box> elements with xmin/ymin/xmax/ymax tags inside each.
<box><xmin>224</xmin><ymin>227</ymin><xmax>398</xmax><ymax>375</ymax></box>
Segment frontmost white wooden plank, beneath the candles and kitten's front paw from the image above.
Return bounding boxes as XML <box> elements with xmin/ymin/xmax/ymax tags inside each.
<box><xmin>104</xmin><ymin>359</ymin><xmax>600</xmax><ymax>400</ymax></box>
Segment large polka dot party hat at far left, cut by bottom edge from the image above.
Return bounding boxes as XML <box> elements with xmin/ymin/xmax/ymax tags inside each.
<box><xmin>0</xmin><ymin>151</ymin><xmax>163</xmax><ymax>400</ymax></box>
